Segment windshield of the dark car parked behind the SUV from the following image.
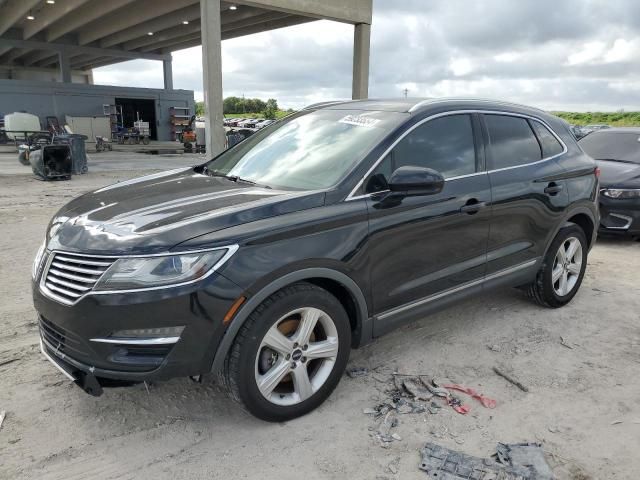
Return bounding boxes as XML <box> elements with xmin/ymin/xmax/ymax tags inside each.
<box><xmin>579</xmin><ymin>130</ymin><xmax>640</xmax><ymax>164</ymax></box>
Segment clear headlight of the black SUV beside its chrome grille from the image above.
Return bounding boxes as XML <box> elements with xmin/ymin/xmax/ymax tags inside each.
<box><xmin>94</xmin><ymin>245</ymin><xmax>238</xmax><ymax>291</ymax></box>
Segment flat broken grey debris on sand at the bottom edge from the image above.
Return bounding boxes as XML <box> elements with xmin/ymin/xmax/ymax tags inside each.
<box><xmin>420</xmin><ymin>442</ymin><xmax>553</xmax><ymax>480</ymax></box>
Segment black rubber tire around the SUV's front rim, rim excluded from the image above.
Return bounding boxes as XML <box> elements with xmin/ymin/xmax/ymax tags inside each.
<box><xmin>223</xmin><ymin>282</ymin><xmax>351</xmax><ymax>422</ymax></box>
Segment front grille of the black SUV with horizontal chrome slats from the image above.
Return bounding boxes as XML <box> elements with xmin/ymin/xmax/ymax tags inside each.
<box><xmin>43</xmin><ymin>252</ymin><xmax>116</xmax><ymax>304</ymax></box>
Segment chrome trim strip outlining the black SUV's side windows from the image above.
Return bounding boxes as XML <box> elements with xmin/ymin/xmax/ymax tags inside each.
<box><xmin>345</xmin><ymin>109</ymin><xmax>569</xmax><ymax>202</ymax></box>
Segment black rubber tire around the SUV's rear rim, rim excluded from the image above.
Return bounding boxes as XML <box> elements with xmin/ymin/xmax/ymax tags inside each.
<box><xmin>525</xmin><ymin>223</ymin><xmax>589</xmax><ymax>308</ymax></box>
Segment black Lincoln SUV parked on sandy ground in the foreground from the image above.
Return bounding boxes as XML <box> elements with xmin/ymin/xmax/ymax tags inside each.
<box><xmin>33</xmin><ymin>99</ymin><xmax>598</xmax><ymax>420</ymax></box>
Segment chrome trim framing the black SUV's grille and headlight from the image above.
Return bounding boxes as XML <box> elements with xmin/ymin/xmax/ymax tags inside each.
<box><xmin>39</xmin><ymin>244</ymin><xmax>240</xmax><ymax>306</ymax></box>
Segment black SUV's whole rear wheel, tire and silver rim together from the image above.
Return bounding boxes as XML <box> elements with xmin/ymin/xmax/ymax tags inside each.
<box><xmin>526</xmin><ymin>224</ymin><xmax>588</xmax><ymax>308</ymax></box>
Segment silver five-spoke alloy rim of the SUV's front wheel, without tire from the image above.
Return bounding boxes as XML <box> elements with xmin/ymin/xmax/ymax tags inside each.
<box><xmin>255</xmin><ymin>307</ymin><xmax>339</xmax><ymax>405</ymax></box>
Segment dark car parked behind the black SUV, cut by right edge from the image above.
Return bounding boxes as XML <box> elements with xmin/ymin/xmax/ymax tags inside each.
<box><xmin>579</xmin><ymin>128</ymin><xmax>640</xmax><ymax>236</ymax></box>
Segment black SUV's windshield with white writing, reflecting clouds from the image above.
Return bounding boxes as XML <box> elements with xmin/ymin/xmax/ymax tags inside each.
<box><xmin>206</xmin><ymin>109</ymin><xmax>407</xmax><ymax>190</ymax></box>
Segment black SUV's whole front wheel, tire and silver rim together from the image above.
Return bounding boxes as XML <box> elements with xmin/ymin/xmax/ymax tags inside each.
<box><xmin>224</xmin><ymin>283</ymin><xmax>351</xmax><ymax>421</ymax></box>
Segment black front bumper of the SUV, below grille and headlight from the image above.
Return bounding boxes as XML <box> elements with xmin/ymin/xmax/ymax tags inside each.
<box><xmin>33</xmin><ymin>274</ymin><xmax>242</xmax><ymax>393</ymax></box>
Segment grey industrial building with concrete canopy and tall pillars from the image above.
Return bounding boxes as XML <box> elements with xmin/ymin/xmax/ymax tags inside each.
<box><xmin>0</xmin><ymin>0</ymin><xmax>372</xmax><ymax>148</ymax></box>
